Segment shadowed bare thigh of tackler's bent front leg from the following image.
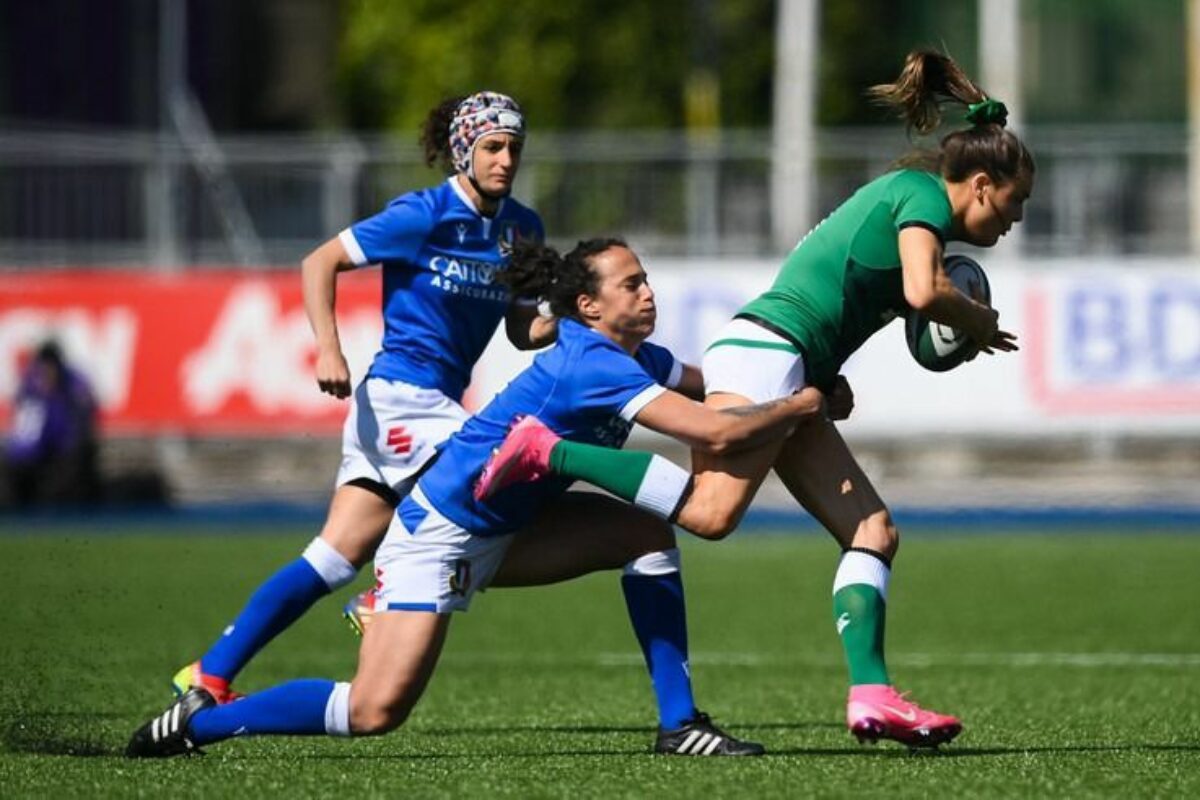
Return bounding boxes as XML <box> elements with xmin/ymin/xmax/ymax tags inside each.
<box><xmin>491</xmin><ymin>492</ymin><xmax>676</xmax><ymax>587</ymax></box>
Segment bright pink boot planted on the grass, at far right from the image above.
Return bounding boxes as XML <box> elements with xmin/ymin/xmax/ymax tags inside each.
<box><xmin>846</xmin><ymin>684</ymin><xmax>962</xmax><ymax>747</ymax></box>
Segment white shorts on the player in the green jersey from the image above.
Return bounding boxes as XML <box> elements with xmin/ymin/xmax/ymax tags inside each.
<box><xmin>701</xmin><ymin>319</ymin><xmax>804</xmax><ymax>403</ymax></box>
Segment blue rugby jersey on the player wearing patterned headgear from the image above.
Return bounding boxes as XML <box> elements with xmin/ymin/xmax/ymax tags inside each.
<box><xmin>341</xmin><ymin>178</ymin><xmax>544</xmax><ymax>401</ymax></box>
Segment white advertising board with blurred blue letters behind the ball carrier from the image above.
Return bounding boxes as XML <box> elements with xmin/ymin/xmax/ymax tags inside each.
<box><xmin>472</xmin><ymin>257</ymin><xmax>1200</xmax><ymax>437</ymax></box>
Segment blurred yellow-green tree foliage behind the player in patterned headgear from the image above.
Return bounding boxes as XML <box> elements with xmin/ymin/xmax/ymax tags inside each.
<box><xmin>338</xmin><ymin>0</ymin><xmax>690</xmax><ymax>130</ymax></box>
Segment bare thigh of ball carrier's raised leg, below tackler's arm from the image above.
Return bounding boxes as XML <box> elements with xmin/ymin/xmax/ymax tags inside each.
<box><xmin>677</xmin><ymin>392</ymin><xmax>782</xmax><ymax>539</ymax></box>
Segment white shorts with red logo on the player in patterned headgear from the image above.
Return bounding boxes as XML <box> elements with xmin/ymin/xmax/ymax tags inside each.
<box><xmin>336</xmin><ymin>378</ymin><xmax>470</xmax><ymax>497</ymax></box>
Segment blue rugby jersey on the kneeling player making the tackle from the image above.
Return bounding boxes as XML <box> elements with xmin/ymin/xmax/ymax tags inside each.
<box><xmin>415</xmin><ymin>319</ymin><xmax>683</xmax><ymax>536</ymax></box>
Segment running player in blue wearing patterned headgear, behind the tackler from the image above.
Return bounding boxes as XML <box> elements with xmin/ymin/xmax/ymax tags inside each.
<box><xmin>174</xmin><ymin>91</ymin><xmax>678</xmax><ymax>724</ymax></box>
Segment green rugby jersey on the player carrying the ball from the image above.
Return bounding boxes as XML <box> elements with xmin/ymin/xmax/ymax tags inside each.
<box><xmin>738</xmin><ymin>169</ymin><xmax>950</xmax><ymax>390</ymax></box>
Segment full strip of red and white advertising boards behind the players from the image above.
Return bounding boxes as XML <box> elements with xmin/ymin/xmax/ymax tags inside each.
<box><xmin>0</xmin><ymin>259</ymin><xmax>1200</xmax><ymax>437</ymax></box>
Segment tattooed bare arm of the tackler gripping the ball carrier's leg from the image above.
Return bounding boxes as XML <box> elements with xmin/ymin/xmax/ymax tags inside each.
<box><xmin>635</xmin><ymin>386</ymin><xmax>824</xmax><ymax>456</ymax></box>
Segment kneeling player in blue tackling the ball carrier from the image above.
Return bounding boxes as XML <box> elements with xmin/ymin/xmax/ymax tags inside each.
<box><xmin>126</xmin><ymin>240</ymin><xmax>823</xmax><ymax>757</ymax></box>
